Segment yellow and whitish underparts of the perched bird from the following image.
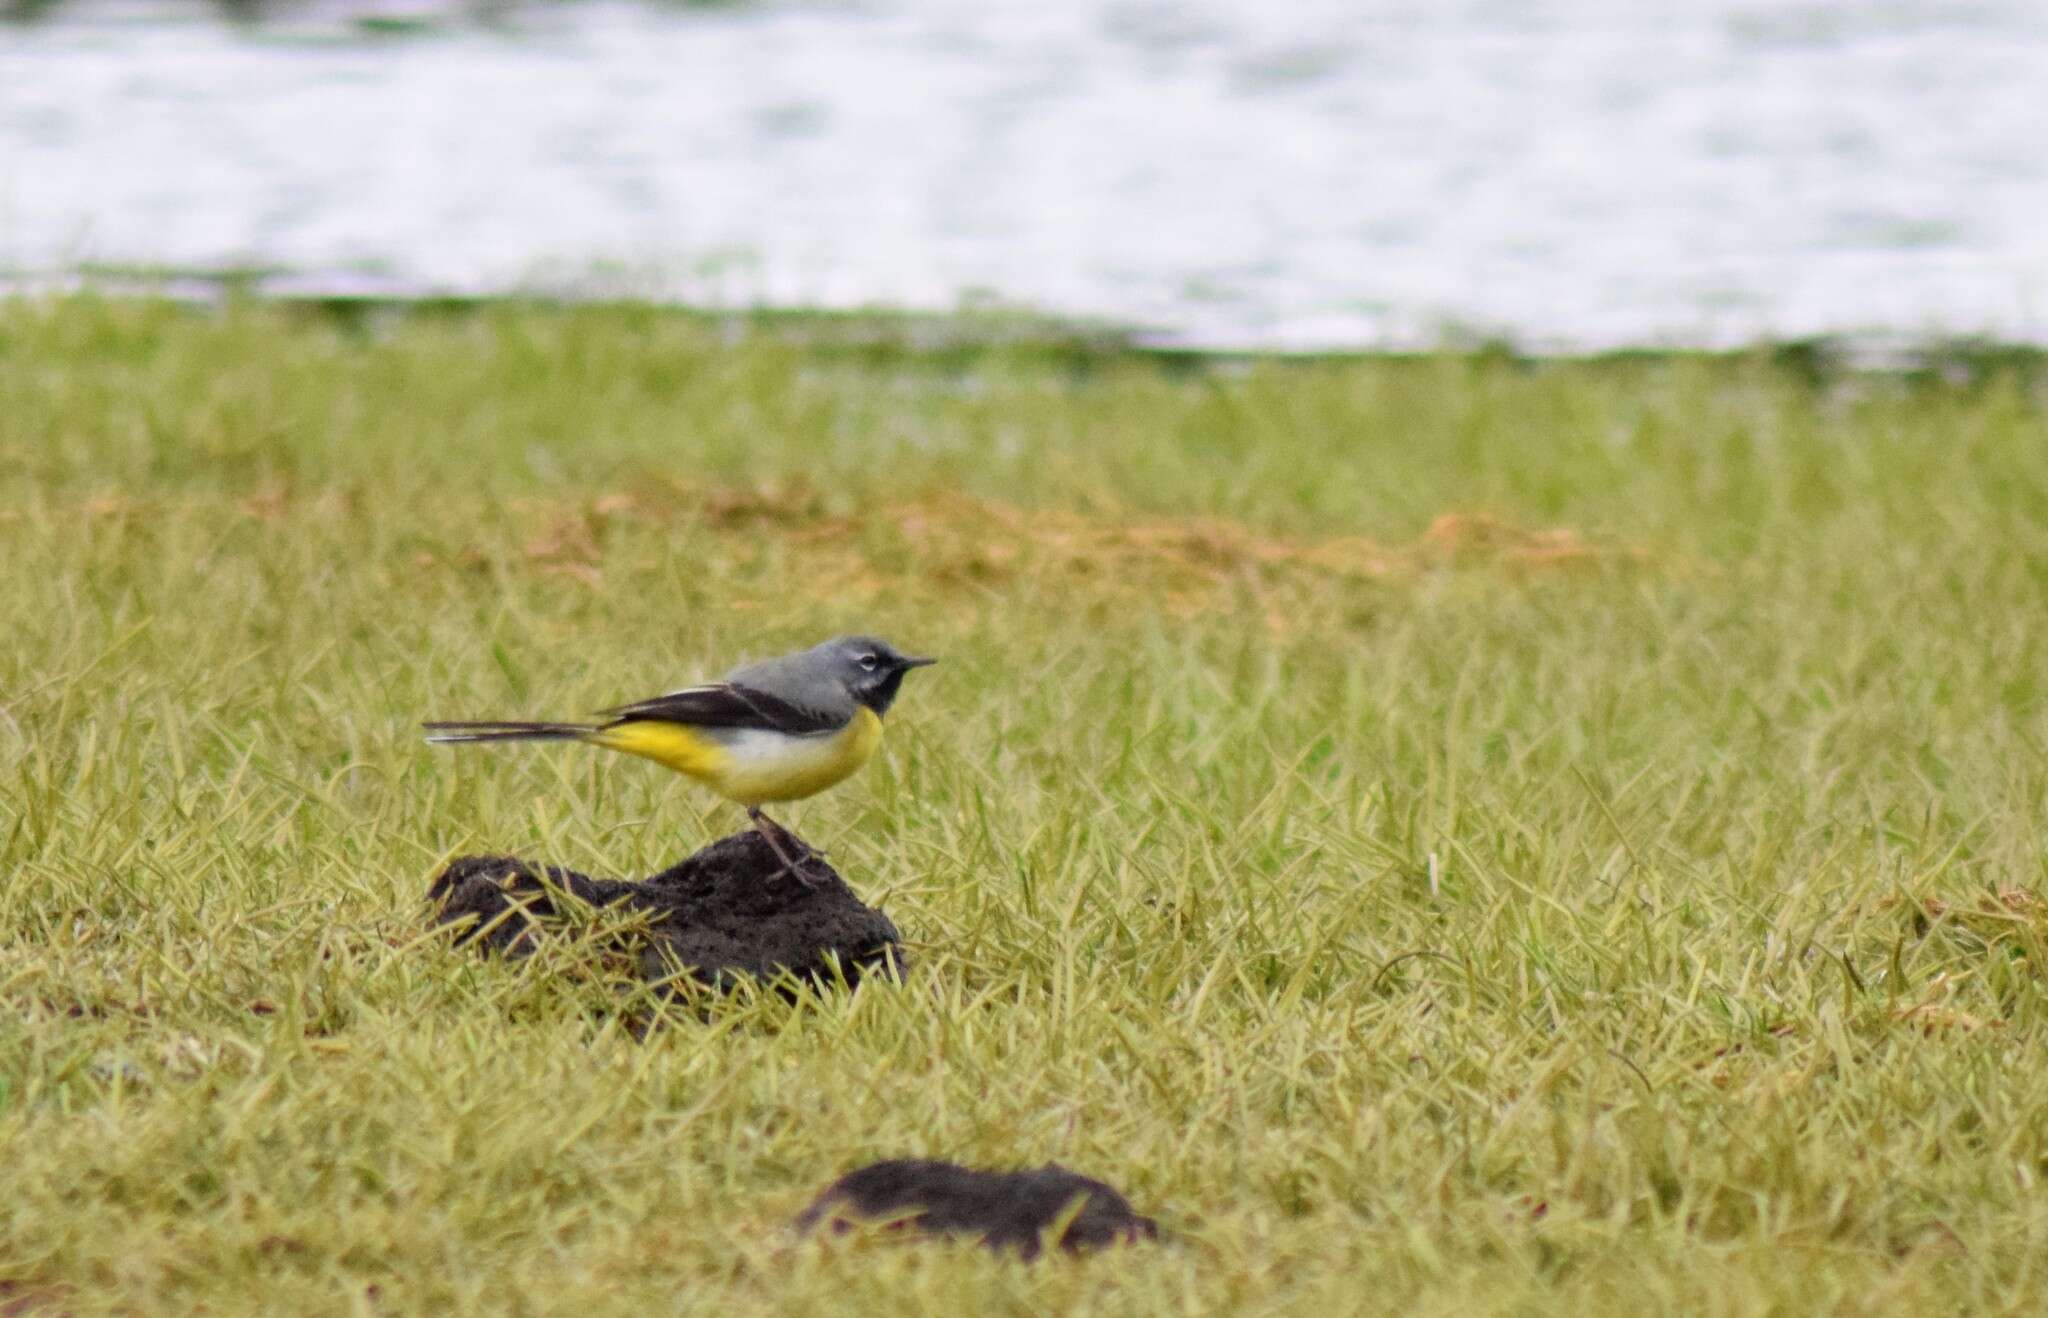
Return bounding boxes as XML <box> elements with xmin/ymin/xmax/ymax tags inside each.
<box><xmin>590</xmin><ymin>706</ymin><xmax>883</xmax><ymax>808</ymax></box>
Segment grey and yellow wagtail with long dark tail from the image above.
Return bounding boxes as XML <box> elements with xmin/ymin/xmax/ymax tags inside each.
<box><xmin>422</xmin><ymin>636</ymin><xmax>938</xmax><ymax>882</ymax></box>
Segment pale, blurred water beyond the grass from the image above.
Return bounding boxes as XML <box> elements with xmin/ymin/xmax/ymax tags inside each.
<box><xmin>0</xmin><ymin>0</ymin><xmax>2048</xmax><ymax>348</ymax></box>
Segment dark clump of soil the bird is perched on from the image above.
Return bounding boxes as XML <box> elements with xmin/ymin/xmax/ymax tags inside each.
<box><xmin>426</xmin><ymin>829</ymin><xmax>901</xmax><ymax>989</ymax></box>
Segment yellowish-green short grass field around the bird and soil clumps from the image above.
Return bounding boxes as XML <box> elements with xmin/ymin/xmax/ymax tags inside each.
<box><xmin>0</xmin><ymin>299</ymin><xmax>2048</xmax><ymax>1314</ymax></box>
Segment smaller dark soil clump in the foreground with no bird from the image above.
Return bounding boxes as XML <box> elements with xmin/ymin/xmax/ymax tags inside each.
<box><xmin>795</xmin><ymin>1158</ymin><xmax>1159</xmax><ymax>1259</ymax></box>
